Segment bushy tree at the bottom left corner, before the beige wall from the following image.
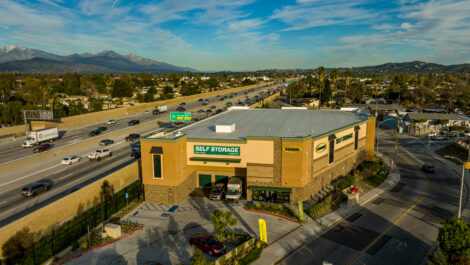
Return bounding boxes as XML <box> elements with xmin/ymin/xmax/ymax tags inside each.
<box><xmin>2</xmin><ymin>227</ymin><xmax>34</xmax><ymax>264</ymax></box>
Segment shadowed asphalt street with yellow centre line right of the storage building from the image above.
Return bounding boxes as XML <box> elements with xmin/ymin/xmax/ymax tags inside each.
<box><xmin>278</xmin><ymin>127</ymin><xmax>468</xmax><ymax>265</ymax></box>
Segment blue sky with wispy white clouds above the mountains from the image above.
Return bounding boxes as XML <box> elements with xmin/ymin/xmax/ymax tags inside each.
<box><xmin>0</xmin><ymin>0</ymin><xmax>470</xmax><ymax>71</ymax></box>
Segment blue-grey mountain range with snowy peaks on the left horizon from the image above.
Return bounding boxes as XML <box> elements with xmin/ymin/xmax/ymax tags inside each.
<box><xmin>0</xmin><ymin>46</ymin><xmax>198</xmax><ymax>73</ymax></box>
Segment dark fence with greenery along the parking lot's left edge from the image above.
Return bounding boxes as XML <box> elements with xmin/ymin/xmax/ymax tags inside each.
<box><xmin>15</xmin><ymin>180</ymin><xmax>143</xmax><ymax>265</ymax></box>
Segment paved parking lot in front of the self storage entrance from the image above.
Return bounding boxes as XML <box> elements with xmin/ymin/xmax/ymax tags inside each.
<box><xmin>67</xmin><ymin>196</ymin><xmax>299</xmax><ymax>265</ymax></box>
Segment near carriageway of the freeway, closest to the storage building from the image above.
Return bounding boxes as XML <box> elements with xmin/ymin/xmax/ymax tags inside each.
<box><xmin>0</xmin><ymin>83</ymin><xmax>286</xmax><ymax>226</ymax></box>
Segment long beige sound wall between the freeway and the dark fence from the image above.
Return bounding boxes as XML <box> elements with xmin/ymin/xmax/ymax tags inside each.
<box><xmin>0</xmin><ymin>162</ymin><xmax>139</xmax><ymax>256</ymax></box>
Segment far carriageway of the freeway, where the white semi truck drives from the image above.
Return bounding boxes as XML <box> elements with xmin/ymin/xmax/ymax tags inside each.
<box><xmin>0</xmin><ymin>83</ymin><xmax>278</xmax><ymax>165</ymax></box>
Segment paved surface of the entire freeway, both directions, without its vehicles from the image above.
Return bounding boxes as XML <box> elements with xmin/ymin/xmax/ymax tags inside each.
<box><xmin>0</xmin><ymin>81</ymin><xmax>284</xmax><ymax>226</ymax></box>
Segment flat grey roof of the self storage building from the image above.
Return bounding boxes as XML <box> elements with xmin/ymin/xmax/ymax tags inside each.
<box><xmin>167</xmin><ymin>109</ymin><xmax>368</xmax><ymax>140</ymax></box>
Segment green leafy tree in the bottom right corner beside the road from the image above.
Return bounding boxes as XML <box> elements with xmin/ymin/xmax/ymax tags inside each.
<box><xmin>428</xmin><ymin>218</ymin><xmax>470</xmax><ymax>264</ymax></box>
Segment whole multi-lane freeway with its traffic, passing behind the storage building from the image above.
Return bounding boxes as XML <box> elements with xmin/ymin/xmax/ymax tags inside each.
<box><xmin>0</xmin><ymin>81</ymin><xmax>286</xmax><ymax>226</ymax></box>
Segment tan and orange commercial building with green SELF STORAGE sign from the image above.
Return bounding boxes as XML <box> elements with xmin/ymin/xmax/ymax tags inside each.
<box><xmin>141</xmin><ymin>109</ymin><xmax>375</xmax><ymax>204</ymax></box>
